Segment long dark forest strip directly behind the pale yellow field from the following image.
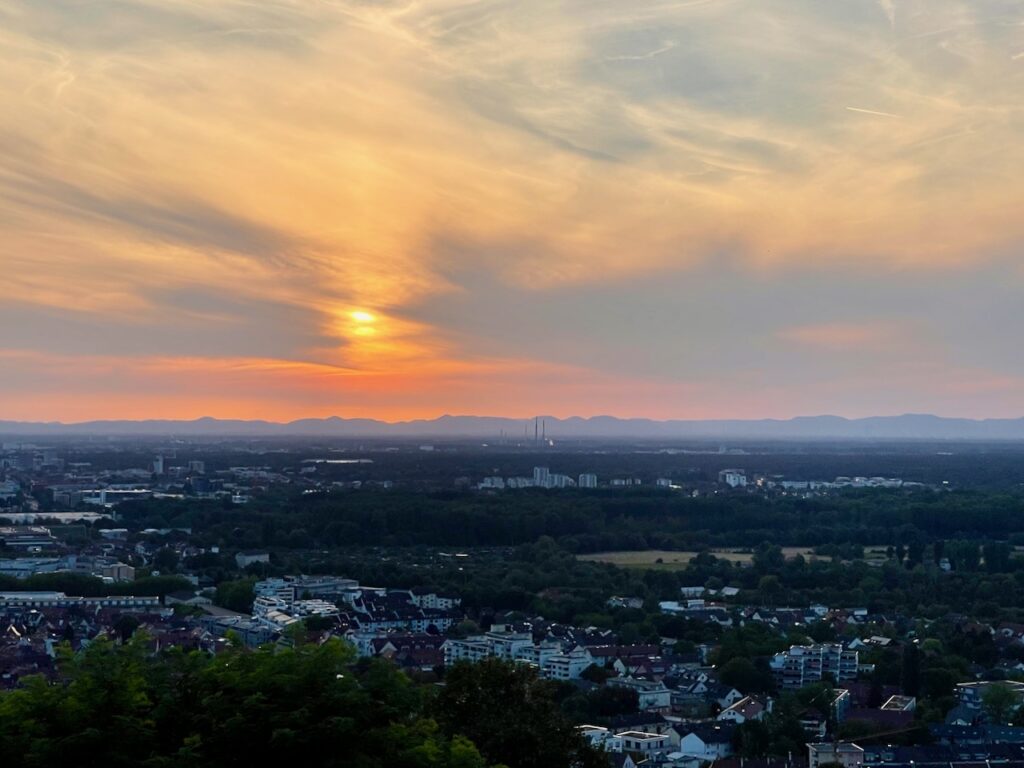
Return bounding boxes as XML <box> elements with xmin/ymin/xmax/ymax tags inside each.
<box><xmin>108</xmin><ymin>489</ymin><xmax>1024</xmax><ymax>552</ymax></box>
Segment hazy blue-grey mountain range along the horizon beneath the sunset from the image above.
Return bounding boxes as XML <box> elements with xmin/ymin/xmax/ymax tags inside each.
<box><xmin>0</xmin><ymin>414</ymin><xmax>1024</xmax><ymax>440</ymax></box>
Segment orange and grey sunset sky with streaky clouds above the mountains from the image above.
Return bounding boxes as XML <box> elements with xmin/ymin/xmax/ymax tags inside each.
<box><xmin>0</xmin><ymin>0</ymin><xmax>1024</xmax><ymax>421</ymax></box>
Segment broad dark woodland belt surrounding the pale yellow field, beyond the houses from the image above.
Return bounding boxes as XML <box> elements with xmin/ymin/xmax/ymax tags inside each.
<box><xmin>90</xmin><ymin>489</ymin><xmax>1024</xmax><ymax>621</ymax></box>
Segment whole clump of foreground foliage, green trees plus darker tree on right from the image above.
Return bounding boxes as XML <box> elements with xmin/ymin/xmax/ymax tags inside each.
<box><xmin>0</xmin><ymin>633</ymin><xmax>606</xmax><ymax>768</ymax></box>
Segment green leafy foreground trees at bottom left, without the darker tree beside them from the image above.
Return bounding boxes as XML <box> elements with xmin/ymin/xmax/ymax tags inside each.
<box><xmin>0</xmin><ymin>637</ymin><xmax>512</xmax><ymax>768</ymax></box>
